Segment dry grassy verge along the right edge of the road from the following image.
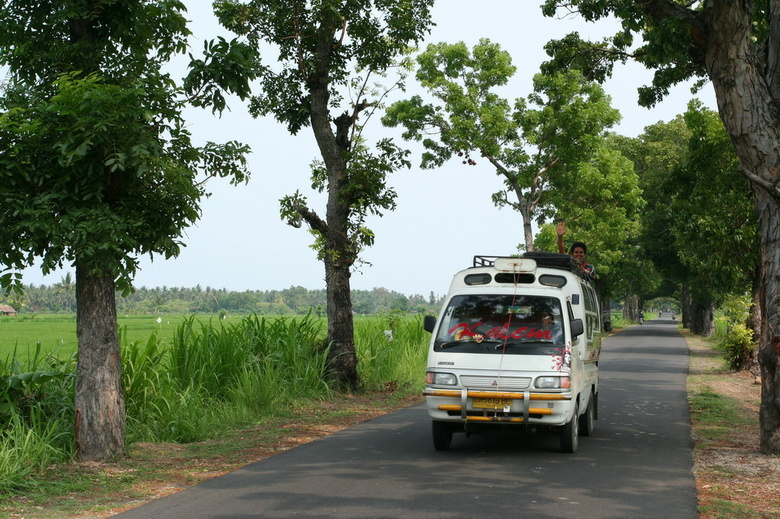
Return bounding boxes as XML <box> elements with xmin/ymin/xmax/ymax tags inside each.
<box><xmin>682</xmin><ymin>331</ymin><xmax>780</xmax><ymax>519</ymax></box>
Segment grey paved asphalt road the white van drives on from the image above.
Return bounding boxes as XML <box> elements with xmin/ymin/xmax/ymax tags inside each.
<box><xmin>118</xmin><ymin>320</ymin><xmax>699</xmax><ymax>519</ymax></box>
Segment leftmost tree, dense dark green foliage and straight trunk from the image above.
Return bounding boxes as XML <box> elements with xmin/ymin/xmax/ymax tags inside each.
<box><xmin>0</xmin><ymin>0</ymin><xmax>246</xmax><ymax>460</ymax></box>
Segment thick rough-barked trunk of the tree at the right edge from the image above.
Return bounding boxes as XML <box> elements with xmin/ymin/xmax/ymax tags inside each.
<box><xmin>702</xmin><ymin>0</ymin><xmax>780</xmax><ymax>454</ymax></box>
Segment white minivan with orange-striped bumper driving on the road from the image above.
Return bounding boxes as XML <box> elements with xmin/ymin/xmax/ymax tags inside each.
<box><xmin>424</xmin><ymin>252</ymin><xmax>601</xmax><ymax>452</ymax></box>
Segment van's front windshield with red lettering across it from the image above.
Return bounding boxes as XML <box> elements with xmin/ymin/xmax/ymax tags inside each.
<box><xmin>434</xmin><ymin>295</ymin><xmax>564</xmax><ymax>355</ymax></box>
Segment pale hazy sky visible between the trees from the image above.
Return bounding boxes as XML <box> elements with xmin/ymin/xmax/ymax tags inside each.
<box><xmin>18</xmin><ymin>0</ymin><xmax>715</xmax><ymax>297</ymax></box>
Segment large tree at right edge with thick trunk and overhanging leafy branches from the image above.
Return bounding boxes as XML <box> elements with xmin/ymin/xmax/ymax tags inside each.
<box><xmin>543</xmin><ymin>0</ymin><xmax>780</xmax><ymax>453</ymax></box>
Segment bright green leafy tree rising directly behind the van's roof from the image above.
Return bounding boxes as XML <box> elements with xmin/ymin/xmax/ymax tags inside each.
<box><xmin>383</xmin><ymin>39</ymin><xmax>638</xmax><ymax>251</ymax></box>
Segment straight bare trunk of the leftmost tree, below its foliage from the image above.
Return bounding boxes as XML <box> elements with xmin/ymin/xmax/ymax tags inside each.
<box><xmin>76</xmin><ymin>265</ymin><xmax>125</xmax><ymax>461</ymax></box>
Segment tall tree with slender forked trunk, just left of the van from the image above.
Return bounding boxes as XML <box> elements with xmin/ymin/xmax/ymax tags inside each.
<box><xmin>200</xmin><ymin>0</ymin><xmax>433</xmax><ymax>389</ymax></box>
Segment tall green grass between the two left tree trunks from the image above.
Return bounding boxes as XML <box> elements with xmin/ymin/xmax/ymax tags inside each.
<box><xmin>122</xmin><ymin>315</ymin><xmax>330</xmax><ymax>442</ymax></box>
